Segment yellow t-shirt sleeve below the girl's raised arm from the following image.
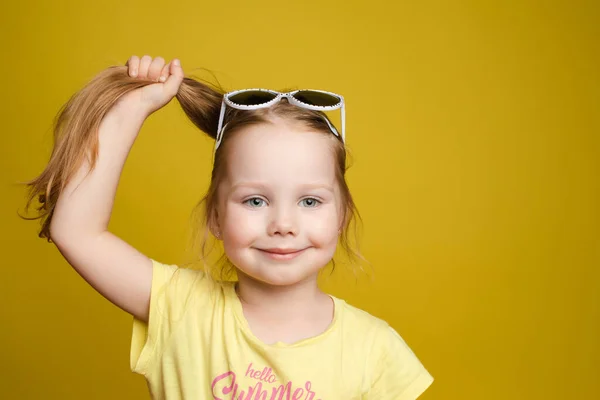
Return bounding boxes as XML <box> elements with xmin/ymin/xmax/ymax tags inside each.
<box><xmin>130</xmin><ymin>260</ymin><xmax>202</xmax><ymax>375</ymax></box>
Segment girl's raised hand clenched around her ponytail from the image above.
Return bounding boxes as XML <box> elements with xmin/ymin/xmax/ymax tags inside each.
<box><xmin>119</xmin><ymin>55</ymin><xmax>183</xmax><ymax>117</ymax></box>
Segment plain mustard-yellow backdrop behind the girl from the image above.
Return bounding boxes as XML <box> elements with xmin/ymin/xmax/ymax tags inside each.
<box><xmin>0</xmin><ymin>0</ymin><xmax>600</xmax><ymax>400</ymax></box>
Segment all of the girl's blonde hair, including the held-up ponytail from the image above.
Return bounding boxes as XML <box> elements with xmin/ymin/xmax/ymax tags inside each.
<box><xmin>22</xmin><ymin>66</ymin><xmax>364</xmax><ymax>276</ymax></box>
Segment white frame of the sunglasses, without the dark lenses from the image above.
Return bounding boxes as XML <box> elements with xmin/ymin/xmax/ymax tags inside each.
<box><xmin>215</xmin><ymin>88</ymin><xmax>346</xmax><ymax>152</ymax></box>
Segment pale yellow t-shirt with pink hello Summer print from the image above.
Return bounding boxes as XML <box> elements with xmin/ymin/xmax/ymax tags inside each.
<box><xmin>131</xmin><ymin>260</ymin><xmax>433</xmax><ymax>400</ymax></box>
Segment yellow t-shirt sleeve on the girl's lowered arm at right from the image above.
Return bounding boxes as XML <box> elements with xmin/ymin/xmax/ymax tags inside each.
<box><xmin>367</xmin><ymin>325</ymin><xmax>433</xmax><ymax>400</ymax></box>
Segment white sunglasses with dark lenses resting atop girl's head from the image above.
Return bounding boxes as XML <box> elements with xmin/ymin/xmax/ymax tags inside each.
<box><xmin>215</xmin><ymin>89</ymin><xmax>346</xmax><ymax>152</ymax></box>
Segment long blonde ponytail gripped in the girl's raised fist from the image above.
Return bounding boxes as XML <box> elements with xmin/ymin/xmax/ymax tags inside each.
<box><xmin>21</xmin><ymin>67</ymin><xmax>224</xmax><ymax>242</ymax></box>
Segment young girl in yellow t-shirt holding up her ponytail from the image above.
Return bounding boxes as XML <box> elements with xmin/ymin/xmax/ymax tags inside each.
<box><xmin>23</xmin><ymin>56</ymin><xmax>433</xmax><ymax>400</ymax></box>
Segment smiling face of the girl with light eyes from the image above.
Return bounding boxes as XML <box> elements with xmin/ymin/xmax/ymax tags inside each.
<box><xmin>217</xmin><ymin>122</ymin><xmax>342</xmax><ymax>286</ymax></box>
